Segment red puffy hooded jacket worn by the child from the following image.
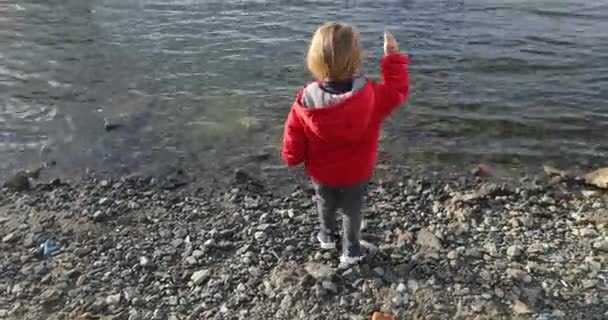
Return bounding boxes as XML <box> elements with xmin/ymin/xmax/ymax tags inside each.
<box><xmin>282</xmin><ymin>54</ymin><xmax>409</xmax><ymax>187</ymax></box>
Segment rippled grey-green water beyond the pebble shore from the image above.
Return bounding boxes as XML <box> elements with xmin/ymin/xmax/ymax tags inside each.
<box><xmin>0</xmin><ymin>0</ymin><xmax>608</xmax><ymax>180</ymax></box>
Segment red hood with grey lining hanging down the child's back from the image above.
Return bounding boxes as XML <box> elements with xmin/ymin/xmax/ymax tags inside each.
<box><xmin>294</xmin><ymin>81</ymin><xmax>374</xmax><ymax>143</ymax></box>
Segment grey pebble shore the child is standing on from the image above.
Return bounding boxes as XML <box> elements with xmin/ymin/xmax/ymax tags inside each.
<box><xmin>0</xmin><ymin>167</ymin><xmax>608</xmax><ymax>320</ymax></box>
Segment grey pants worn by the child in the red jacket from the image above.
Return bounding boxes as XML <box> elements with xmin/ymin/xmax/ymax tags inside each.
<box><xmin>315</xmin><ymin>182</ymin><xmax>367</xmax><ymax>256</ymax></box>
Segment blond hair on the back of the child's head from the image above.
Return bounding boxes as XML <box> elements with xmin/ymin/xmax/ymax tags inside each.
<box><xmin>307</xmin><ymin>22</ymin><xmax>361</xmax><ymax>81</ymax></box>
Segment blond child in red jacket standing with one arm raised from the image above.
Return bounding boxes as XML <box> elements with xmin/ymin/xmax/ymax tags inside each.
<box><xmin>282</xmin><ymin>22</ymin><xmax>409</xmax><ymax>265</ymax></box>
